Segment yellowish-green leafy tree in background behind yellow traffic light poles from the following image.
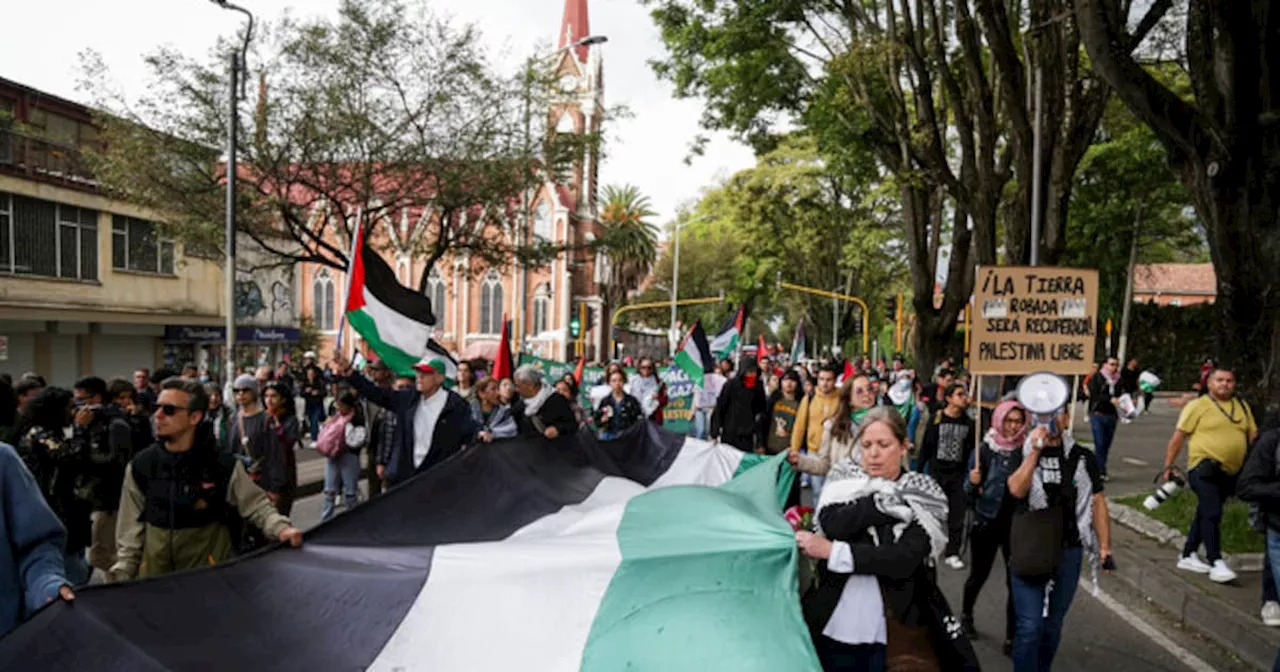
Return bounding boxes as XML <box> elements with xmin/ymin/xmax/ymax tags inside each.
<box><xmin>624</xmin><ymin>134</ymin><xmax>905</xmax><ymax>353</ymax></box>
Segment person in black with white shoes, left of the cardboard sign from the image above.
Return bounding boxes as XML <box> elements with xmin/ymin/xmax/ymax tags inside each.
<box><xmin>919</xmin><ymin>383</ymin><xmax>977</xmax><ymax>570</ymax></box>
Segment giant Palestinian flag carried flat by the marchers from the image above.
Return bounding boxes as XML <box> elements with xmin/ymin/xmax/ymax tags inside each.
<box><xmin>0</xmin><ymin>422</ymin><xmax>820</xmax><ymax>672</ymax></box>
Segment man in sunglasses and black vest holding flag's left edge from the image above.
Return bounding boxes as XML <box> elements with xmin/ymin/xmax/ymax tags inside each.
<box><xmin>108</xmin><ymin>379</ymin><xmax>302</xmax><ymax>581</ymax></box>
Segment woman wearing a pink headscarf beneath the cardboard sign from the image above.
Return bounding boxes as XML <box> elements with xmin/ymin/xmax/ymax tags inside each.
<box><xmin>960</xmin><ymin>401</ymin><xmax>1027</xmax><ymax>655</ymax></box>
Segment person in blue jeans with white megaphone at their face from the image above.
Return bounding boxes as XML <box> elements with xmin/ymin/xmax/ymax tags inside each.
<box><xmin>1007</xmin><ymin>413</ymin><xmax>1114</xmax><ymax>672</ymax></box>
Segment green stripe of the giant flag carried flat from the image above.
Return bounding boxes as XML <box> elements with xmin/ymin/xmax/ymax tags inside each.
<box><xmin>581</xmin><ymin>456</ymin><xmax>820</xmax><ymax>672</ymax></box>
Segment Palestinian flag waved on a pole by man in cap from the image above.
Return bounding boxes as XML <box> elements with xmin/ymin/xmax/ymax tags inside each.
<box><xmin>344</xmin><ymin>225</ymin><xmax>435</xmax><ymax>375</ymax></box>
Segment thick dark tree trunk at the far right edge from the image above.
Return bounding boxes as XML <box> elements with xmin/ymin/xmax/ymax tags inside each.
<box><xmin>1076</xmin><ymin>0</ymin><xmax>1280</xmax><ymax>415</ymax></box>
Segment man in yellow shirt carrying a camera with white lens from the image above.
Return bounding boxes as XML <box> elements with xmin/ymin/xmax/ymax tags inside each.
<box><xmin>1162</xmin><ymin>366</ymin><xmax>1258</xmax><ymax>584</ymax></box>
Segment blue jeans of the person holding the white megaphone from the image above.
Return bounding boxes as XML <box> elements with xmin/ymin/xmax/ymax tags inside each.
<box><xmin>1012</xmin><ymin>548</ymin><xmax>1084</xmax><ymax>672</ymax></box>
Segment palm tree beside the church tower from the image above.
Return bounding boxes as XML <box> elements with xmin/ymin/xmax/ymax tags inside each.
<box><xmin>600</xmin><ymin>184</ymin><xmax>658</xmax><ymax>313</ymax></box>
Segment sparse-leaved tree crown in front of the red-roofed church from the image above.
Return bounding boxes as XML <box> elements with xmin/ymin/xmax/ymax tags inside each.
<box><xmin>86</xmin><ymin>0</ymin><xmax>596</xmax><ymax>283</ymax></box>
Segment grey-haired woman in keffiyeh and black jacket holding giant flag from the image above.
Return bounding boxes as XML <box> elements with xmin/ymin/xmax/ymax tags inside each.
<box><xmin>796</xmin><ymin>407</ymin><xmax>977</xmax><ymax>672</ymax></box>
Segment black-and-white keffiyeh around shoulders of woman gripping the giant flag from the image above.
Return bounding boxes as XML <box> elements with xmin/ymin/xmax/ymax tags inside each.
<box><xmin>814</xmin><ymin>460</ymin><xmax>947</xmax><ymax>561</ymax></box>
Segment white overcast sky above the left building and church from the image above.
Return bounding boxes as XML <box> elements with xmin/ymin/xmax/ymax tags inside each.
<box><xmin>0</xmin><ymin>0</ymin><xmax>753</xmax><ymax>224</ymax></box>
